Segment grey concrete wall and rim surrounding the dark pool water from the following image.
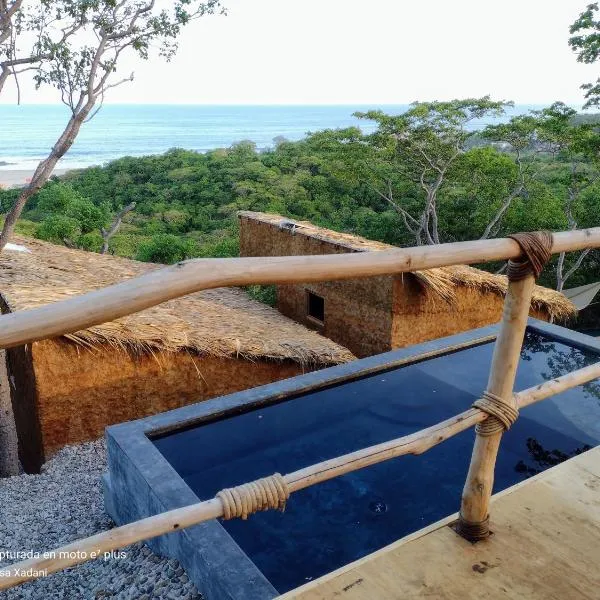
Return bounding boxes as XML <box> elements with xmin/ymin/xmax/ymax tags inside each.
<box><xmin>105</xmin><ymin>319</ymin><xmax>600</xmax><ymax>600</ymax></box>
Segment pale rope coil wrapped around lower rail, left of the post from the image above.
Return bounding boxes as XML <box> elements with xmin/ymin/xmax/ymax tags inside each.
<box><xmin>217</xmin><ymin>473</ymin><xmax>290</xmax><ymax>520</ymax></box>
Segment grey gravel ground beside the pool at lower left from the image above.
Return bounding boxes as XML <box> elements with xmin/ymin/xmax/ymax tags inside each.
<box><xmin>0</xmin><ymin>440</ymin><xmax>201</xmax><ymax>600</ymax></box>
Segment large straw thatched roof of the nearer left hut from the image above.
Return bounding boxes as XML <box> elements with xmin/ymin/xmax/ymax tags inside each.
<box><xmin>0</xmin><ymin>238</ymin><xmax>354</xmax><ymax>366</ymax></box>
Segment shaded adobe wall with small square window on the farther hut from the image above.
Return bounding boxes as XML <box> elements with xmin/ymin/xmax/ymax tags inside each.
<box><xmin>240</xmin><ymin>216</ymin><xmax>393</xmax><ymax>357</ymax></box>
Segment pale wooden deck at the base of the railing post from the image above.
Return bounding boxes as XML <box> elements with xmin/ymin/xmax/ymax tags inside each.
<box><xmin>280</xmin><ymin>447</ymin><xmax>600</xmax><ymax>600</ymax></box>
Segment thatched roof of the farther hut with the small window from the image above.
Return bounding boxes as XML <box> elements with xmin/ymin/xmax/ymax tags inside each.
<box><xmin>239</xmin><ymin>211</ymin><xmax>577</xmax><ymax>321</ymax></box>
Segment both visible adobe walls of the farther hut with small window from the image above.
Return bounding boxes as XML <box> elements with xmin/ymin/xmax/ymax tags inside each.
<box><xmin>240</xmin><ymin>215</ymin><xmax>548</xmax><ymax>358</ymax></box>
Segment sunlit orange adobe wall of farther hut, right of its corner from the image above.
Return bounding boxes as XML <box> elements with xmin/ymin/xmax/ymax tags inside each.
<box><xmin>392</xmin><ymin>277</ymin><xmax>548</xmax><ymax>348</ymax></box>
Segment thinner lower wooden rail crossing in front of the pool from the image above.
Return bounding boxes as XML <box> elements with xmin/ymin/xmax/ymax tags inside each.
<box><xmin>0</xmin><ymin>362</ymin><xmax>600</xmax><ymax>590</ymax></box>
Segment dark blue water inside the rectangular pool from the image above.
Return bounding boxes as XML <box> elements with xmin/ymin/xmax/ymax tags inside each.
<box><xmin>155</xmin><ymin>332</ymin><xmax>600</xmax><ymax>592</ymax></box>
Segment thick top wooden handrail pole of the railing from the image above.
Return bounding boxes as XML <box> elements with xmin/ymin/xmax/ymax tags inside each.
<box><xmin>0</xmin><ymin>227</ymin><xmax>600</xmax><ymax>348</ymax></box>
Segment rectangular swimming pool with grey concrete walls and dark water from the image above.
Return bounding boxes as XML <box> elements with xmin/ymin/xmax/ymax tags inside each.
<box><xmin>107</xmin><ymin>320</ymin><xmax>600</xmax><ymax>598</ymax></box>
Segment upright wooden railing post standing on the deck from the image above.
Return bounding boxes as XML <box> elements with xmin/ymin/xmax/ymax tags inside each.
<box><xmin>457</xmin><ymin>275</ymin><xmax>535</xmax><ymax>541</ymax></box>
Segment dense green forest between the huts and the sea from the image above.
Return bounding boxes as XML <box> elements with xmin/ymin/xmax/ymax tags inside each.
<box><xmin>0</xmin><ymin>97</ymin><xmax>600</xmax><ymax>289</ymax></box>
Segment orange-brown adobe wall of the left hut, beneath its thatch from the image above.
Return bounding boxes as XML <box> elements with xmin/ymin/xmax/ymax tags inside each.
<box><xmin>11</xmin><ymin>339</ymin><xmax>303</xmax><ymax>472</ymax></box>
